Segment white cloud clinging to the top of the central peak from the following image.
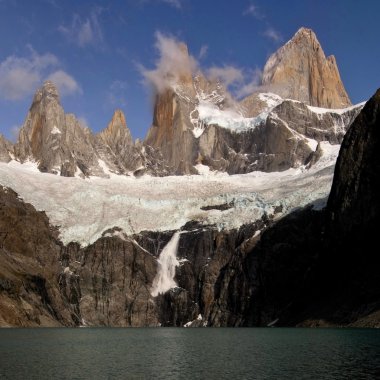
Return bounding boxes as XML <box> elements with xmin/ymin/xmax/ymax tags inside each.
<box><xmin>138</xmin><ymin>32</ymin><xmax>198</xmax><ymax>93</ymax></box>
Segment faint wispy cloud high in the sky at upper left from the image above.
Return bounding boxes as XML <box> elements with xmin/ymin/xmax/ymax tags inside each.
<box><xmin>58</xmin><ymin>8</ymin><xmax>104</xmax><ymax>47</ymax></box>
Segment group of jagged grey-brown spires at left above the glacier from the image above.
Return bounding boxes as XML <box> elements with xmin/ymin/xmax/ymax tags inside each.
<box><xmin>10</xmin><ymin>81</ymin><xmax>170</xmax><ymax>178</ymax></box>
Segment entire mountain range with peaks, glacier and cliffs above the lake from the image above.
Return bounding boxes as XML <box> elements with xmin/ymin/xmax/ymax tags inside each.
<box><xmin>0</xmin><ymin>28</ymin><xmax>380</xmax><ymax>327</ymax></box>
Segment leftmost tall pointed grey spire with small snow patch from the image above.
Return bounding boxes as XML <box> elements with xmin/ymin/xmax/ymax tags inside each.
<box><xmin>15</xmin><ymin>81</ymin><xmax>104</xmax><ymax>177</ymax></box>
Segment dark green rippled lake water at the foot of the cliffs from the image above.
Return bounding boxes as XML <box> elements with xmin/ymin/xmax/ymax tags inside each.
<box><xmin>0</xmin><ymin>328</ymin><xmax>380</xmax><ymax>380</ymax></box>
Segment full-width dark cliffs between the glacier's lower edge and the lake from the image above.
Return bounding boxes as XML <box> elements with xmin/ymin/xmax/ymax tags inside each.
<box><xmin>0</xmin><ymin>91</ymin><xmax>380</xmax><ymax>326</ymax></box>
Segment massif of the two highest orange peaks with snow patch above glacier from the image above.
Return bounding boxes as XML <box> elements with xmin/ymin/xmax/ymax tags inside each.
<box><xmin>146</xmin><ymin>28</ymin><xmax>360</xmax><ymax>174</ymax></box>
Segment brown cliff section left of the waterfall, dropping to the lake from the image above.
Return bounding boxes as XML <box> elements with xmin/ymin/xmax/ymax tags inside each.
<box><xmin>61</xmin><ymin>237</ymin><xmax>159</xmax><ymax>327</ymax></box>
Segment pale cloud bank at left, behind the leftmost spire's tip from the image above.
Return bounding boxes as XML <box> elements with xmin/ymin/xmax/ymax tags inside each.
<box><xmin>0</xmin><ymin>45</ymin><xmax>80</xmax><ymax>100</ymax></box>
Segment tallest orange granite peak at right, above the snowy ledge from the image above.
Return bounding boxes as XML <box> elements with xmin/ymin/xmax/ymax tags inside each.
<box><xmin>262</xmin><ymin>27</ymin><xmax>351</xmax><ymax>108</ymax></box>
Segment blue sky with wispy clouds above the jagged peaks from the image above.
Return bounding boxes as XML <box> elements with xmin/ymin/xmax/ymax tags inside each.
<box><xmin>0</xmin><ymin>0</ymin><xmax>380</xmax><ymax>139</ymax></box>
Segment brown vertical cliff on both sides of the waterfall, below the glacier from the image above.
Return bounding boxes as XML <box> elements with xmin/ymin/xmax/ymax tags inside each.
<box><xmin>61</xmin><ymin>220</ymin><xmax>268</xmax><ymax>326</ymax></box>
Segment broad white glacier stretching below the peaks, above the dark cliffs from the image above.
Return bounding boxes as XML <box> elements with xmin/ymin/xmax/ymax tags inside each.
<box><xmin>0</xmin><ymin>143</ymin><xmax>339</xmax><ymax>245</ymax></box>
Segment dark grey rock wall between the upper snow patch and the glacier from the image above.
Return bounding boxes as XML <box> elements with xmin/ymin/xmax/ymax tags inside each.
<box><xmin>197</xmin><ymin>100</ymin><xmax>361</xmax><ymax>174</ymax></box>
